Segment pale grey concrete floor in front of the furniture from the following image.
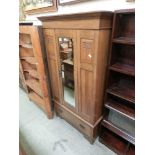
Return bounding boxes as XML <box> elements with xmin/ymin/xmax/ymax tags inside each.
<box><xmin>19</xmin><ymin>89</ymin><xmax>116</xmax><ymax>155</ymax></box>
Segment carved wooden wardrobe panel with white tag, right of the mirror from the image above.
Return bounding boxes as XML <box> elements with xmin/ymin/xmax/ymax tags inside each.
<box><xmin>77</xmin><ymin>30</ymin><xmax>98</xmax><ymax>124</ymax></box>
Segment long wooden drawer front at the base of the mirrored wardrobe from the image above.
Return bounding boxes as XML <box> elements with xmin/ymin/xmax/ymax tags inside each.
<box><xmin>55</xmin><ymin>104</ymin><xmax>93</xmax><ymax>138</ymax></box>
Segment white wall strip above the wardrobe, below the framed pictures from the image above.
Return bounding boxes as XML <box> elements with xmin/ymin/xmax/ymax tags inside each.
<box><xmin>26</xmin><ymin>0</ymin><xmax>135</xmax><ymax>25</ymax></box>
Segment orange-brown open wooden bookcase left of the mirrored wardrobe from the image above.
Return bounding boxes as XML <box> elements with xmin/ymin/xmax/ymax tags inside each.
<box><xmin>19</xmin><ymin>24</ymin><xmax>53</xmax><ymax>118</ymax></box>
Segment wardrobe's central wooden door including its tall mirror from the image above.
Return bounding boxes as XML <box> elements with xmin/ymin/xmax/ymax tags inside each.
<box><xmin>55</xmin><ymin>29</ymin><xmax>78</xmax><ymax>113</ymax></box>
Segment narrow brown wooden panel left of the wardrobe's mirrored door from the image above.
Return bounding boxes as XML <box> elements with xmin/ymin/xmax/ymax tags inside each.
<box><xmin>44</xmin><ymin>29</ymin><xmax>60</xmax><ymax>101</ymax></box>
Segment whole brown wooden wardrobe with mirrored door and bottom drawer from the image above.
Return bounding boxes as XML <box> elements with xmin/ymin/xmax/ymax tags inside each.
<box><xmin>39</xmin><ymin>11</ymin><xmax>113</xmax><ymax>143</ymax></box>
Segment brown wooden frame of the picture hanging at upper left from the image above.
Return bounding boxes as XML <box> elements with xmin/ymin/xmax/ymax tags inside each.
<box><xmin>25</xmin><ymin>0</ymin><xmax>58</xmax><ymax>15</ymax></box>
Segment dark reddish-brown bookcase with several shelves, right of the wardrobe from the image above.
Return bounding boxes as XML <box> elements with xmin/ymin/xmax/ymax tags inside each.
<box><xmin>99</xmin><ymin>9</ymin><xmax>135</xmax><ymax>155</ymax></box>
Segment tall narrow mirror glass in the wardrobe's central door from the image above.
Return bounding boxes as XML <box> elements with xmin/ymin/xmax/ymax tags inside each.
<box><xmin>59</xmin><ymin>37</ymin><xmax>75</xmax><ymax>107</ymax></box>
